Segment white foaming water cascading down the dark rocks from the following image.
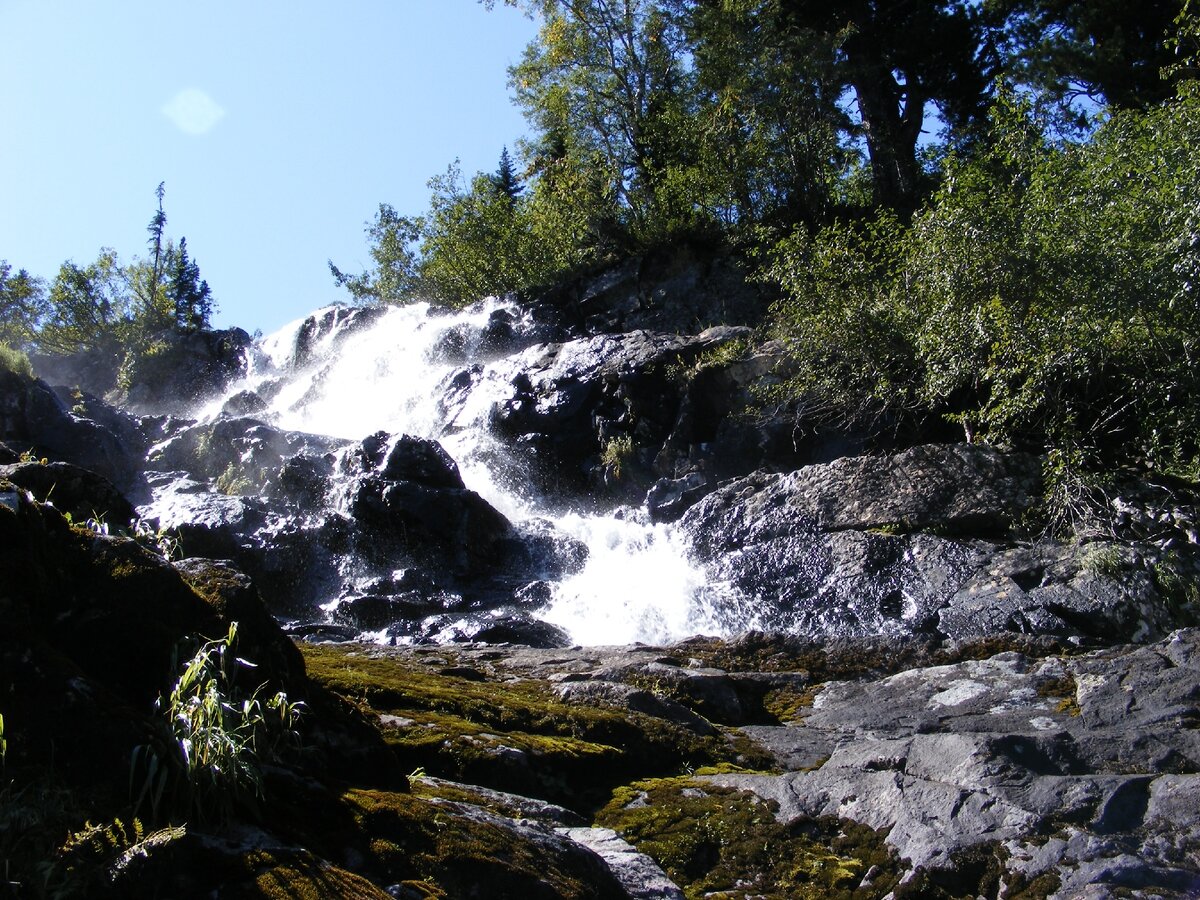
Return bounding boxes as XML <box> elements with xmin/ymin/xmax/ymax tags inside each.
<box><xmin>202</xmin><ymin>300</ymin><xmax>724</xmax><ymax>644</ymax></box>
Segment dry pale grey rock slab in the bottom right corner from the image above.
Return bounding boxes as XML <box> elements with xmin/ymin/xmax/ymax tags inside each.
<box><xmin>712</xmin><ymin>630</ymin><xmax>1200</xmax><ymax>896</ymax></box>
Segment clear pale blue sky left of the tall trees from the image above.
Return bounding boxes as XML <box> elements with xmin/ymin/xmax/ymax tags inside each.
<box><xmin>0</xmin><ymin>0</ymin><xmax>536</xmax><ymax>331</ymax></box>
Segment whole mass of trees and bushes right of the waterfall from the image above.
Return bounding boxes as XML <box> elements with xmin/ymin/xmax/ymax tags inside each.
<box><xmin>338</xmin><ymin>0</ymin><xmax>1200</xmax><ymax>494</ymax></box>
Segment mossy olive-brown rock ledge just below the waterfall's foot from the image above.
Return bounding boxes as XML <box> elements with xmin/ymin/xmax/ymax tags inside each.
<box><xmin>302</xmin><ymin>646</ymin><xmax>739</xmax><ymax>811</ymax></box>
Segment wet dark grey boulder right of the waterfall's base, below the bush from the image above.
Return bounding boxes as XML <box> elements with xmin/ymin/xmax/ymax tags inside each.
<box><xmin>682</xmin><ymin>444</ymin><xmax>1194</xmax><ymax>642</ymax></box>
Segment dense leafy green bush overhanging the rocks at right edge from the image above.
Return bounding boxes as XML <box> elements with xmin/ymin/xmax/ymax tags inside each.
<box><xmin>766</xmin><ymin>94</ymin><xmax>1200</xmax><ymax>493</ymax></box>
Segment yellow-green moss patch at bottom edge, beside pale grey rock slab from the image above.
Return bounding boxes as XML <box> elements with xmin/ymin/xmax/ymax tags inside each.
<box><xmin>596</xmin><ymin>778</ymin><xmax>901</xmax><ymax>900</ymax></box>
